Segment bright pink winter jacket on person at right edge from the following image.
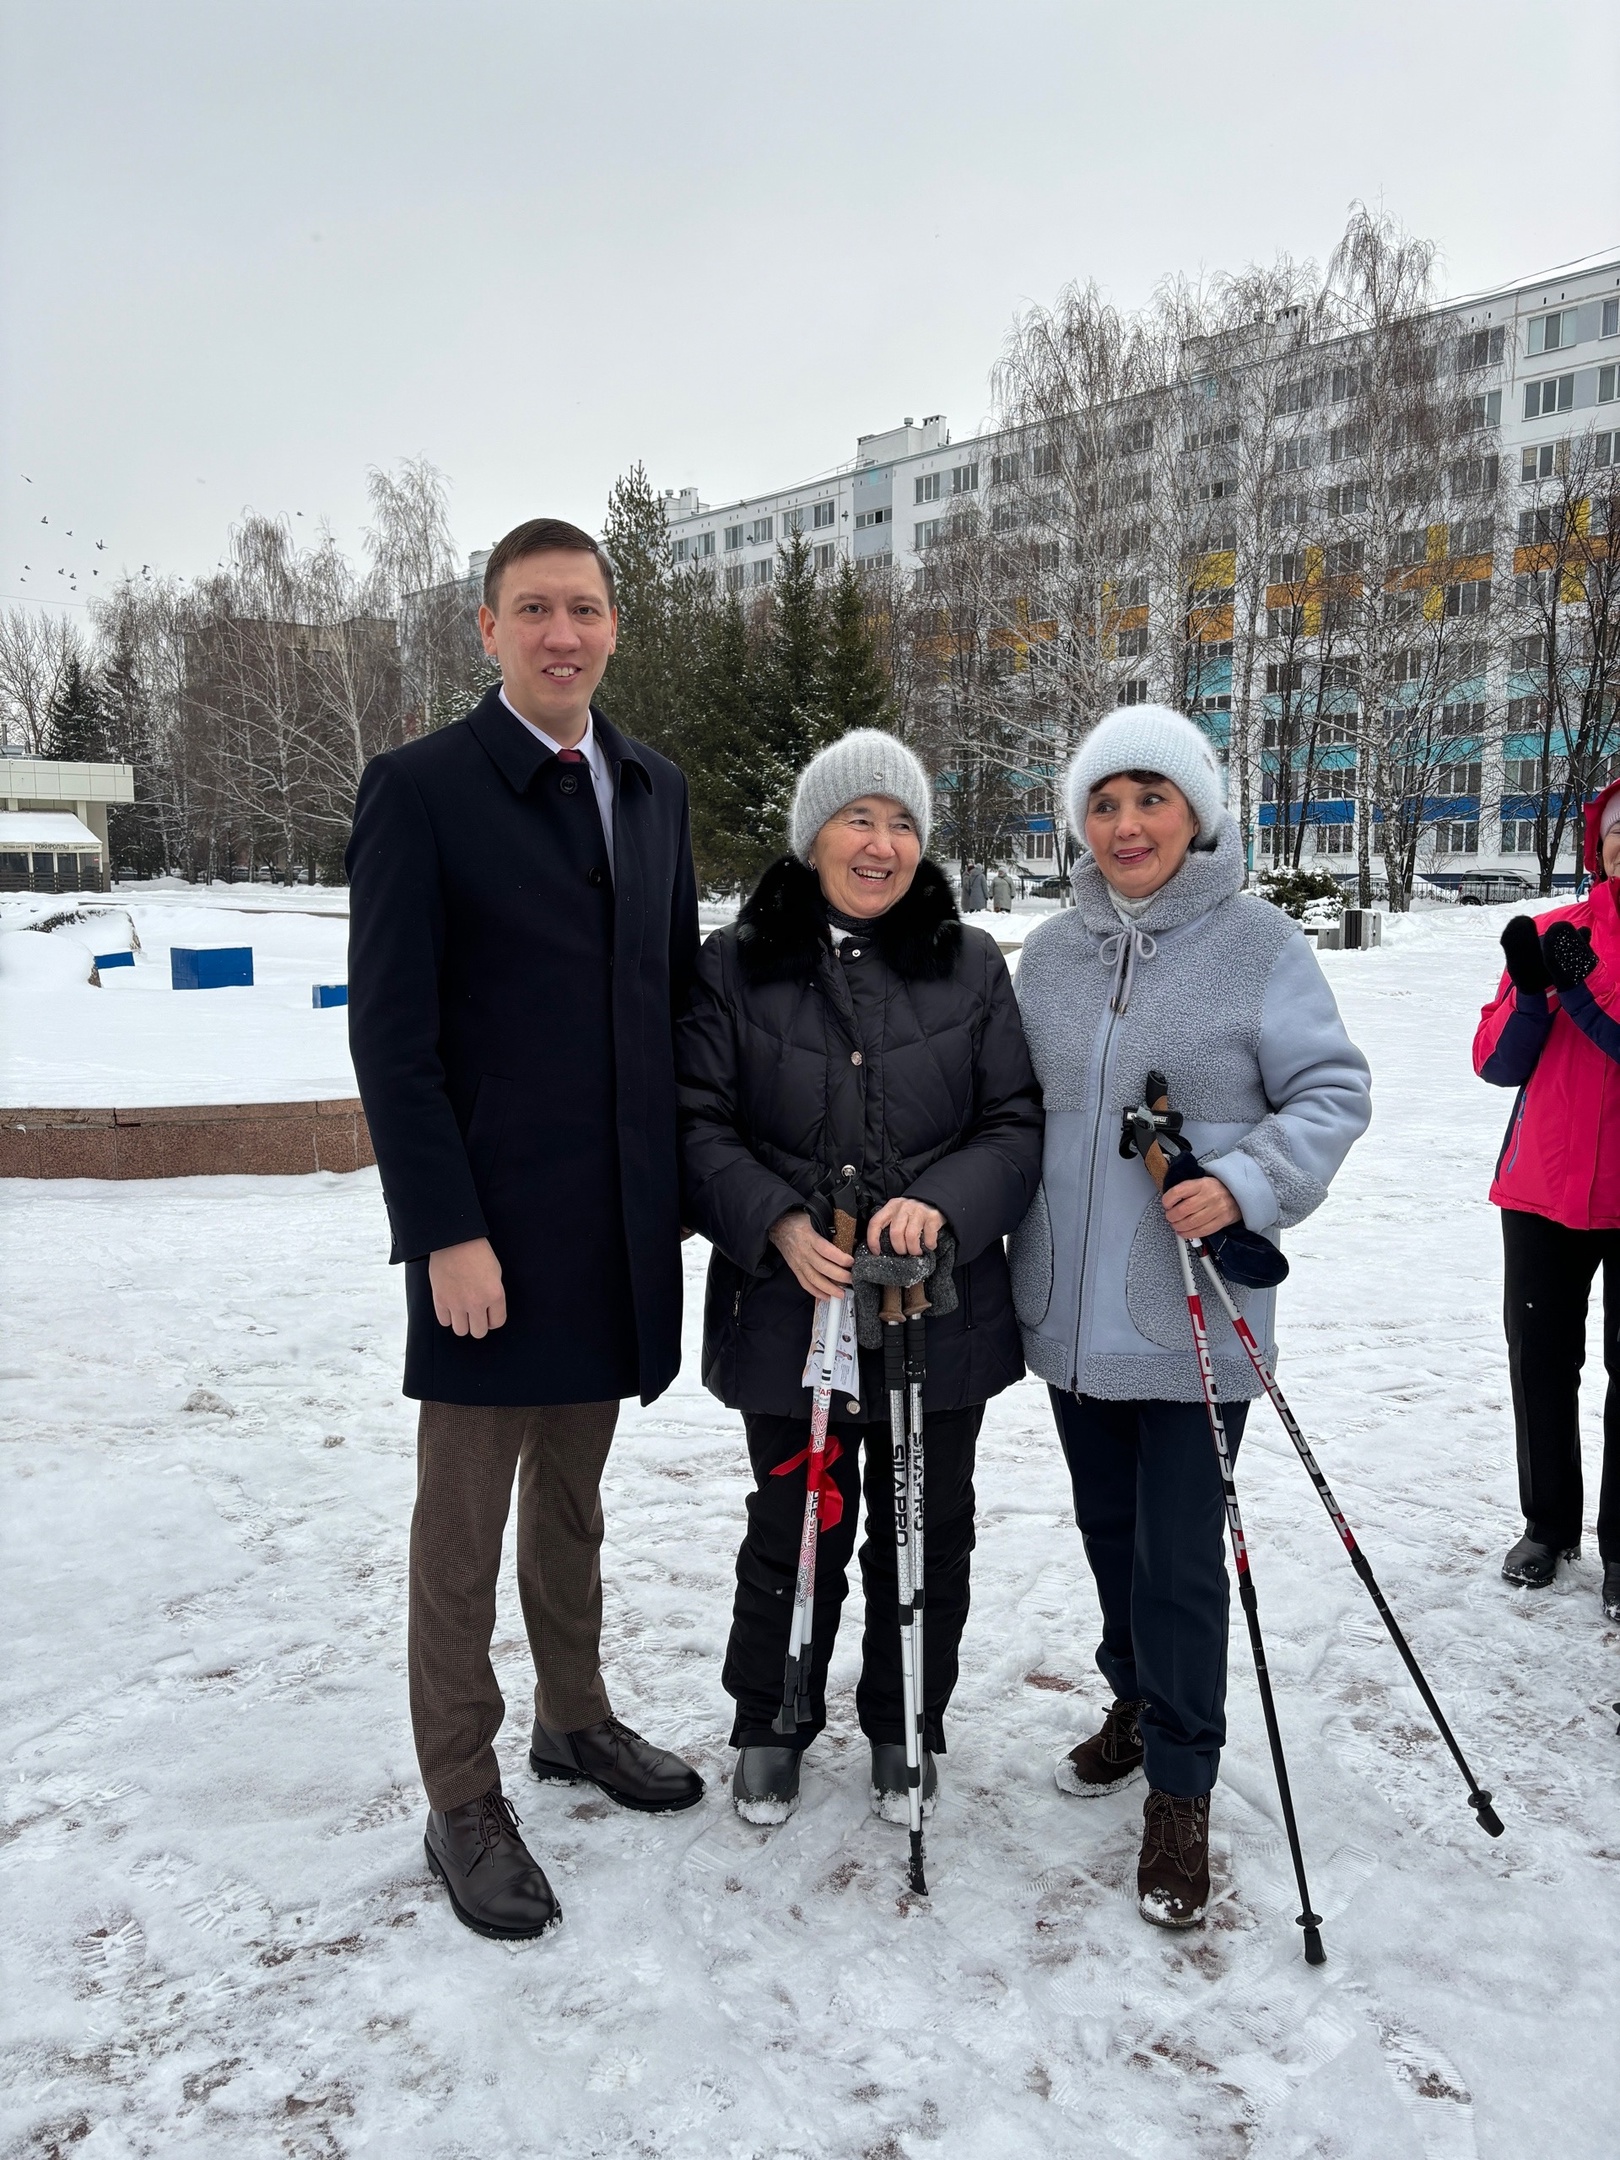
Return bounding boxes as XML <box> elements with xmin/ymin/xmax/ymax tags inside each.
<box><xmin>1473</xmin><ymin>879</ymin><xmax>1620</xmax><ymax>1229</ymax></box>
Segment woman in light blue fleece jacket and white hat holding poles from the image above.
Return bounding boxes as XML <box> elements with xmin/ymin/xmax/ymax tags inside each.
<box><xmin>1011</xmin><ymin>706</ymin><xmax>1372</xmax><ymax>1927</ymax></box>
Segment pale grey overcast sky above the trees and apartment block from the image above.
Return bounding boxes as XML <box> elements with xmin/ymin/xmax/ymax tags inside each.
<box><xmin>0</xmin><ymin>0</ymin><xmax>1620</xmax><ymax>598</ymax></box>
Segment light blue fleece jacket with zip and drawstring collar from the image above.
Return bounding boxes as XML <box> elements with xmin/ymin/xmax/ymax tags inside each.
<box><xmin>1009</xmin><ymin>819</ymin><xmax>1372</xmax><ymax>1402</ymax></box>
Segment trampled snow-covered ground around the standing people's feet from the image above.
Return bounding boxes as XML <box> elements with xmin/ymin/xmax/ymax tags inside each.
<box><xmin>0</xmin><ymin>909</ymin><xmax>1620</xmax><ymax>2160</ymax></box>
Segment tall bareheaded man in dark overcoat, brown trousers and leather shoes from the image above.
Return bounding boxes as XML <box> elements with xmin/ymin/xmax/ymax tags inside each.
<box><xmin>346</xmin><ymin>518</ymin><xmax>702</xmax><ymax>1938</ymax></box>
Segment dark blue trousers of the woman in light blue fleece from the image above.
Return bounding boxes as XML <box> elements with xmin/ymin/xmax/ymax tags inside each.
<box><xmin>1050</xmin><ymin>1387</ymin><xmax>1248</xmax><ymax>1797</ymax></box>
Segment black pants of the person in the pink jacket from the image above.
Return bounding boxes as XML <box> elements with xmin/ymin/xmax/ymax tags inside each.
<box><xmin>1501</xmin><ymin>1207</ymin><xmax>1620</xmax><ymax>1560</ymax></box>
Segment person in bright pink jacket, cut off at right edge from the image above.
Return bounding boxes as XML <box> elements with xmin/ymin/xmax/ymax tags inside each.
<box><xmin>1473</xmin><ymin>780</ymin><xmax>1620</xmax><ymax>1620</ymax></box>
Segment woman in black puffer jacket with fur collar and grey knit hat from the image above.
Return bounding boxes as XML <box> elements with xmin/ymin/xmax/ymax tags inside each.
<box><xmin>676</xmin><ymin>730</ymin><xmax>1041</xmax><ymax>1823</ymax></box>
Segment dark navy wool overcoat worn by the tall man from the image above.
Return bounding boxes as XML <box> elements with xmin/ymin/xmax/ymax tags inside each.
<box><xmin>346</xmin><ymin>691</ymin><xmax>698</xmax><ymax>1404</ymax></box>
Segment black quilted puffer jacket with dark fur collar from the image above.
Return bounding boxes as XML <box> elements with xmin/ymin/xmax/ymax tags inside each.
<box><xmin>676</xmin><ymin>855</ymin><xmax>1041</xmax><ymax>1417</ymax></box>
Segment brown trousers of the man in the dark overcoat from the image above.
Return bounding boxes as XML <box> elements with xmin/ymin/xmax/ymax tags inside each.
<box><xmin>408</xmin><ymin>1402</ymin><xmax>618</xmax><ymax>1808</ymax></box>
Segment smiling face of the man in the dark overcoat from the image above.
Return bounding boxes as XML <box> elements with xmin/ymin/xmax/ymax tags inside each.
<box><xmin>477</xmin><ymin>549</ymin><xmax>618</xmax><ymax>750</ymax></box>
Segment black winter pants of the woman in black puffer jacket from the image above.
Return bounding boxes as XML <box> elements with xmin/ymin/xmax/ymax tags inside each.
<box><xmin>721</xmin><ymin>1404</ymin><xmax>985</xmax><ymax>1754</ymax></box>
